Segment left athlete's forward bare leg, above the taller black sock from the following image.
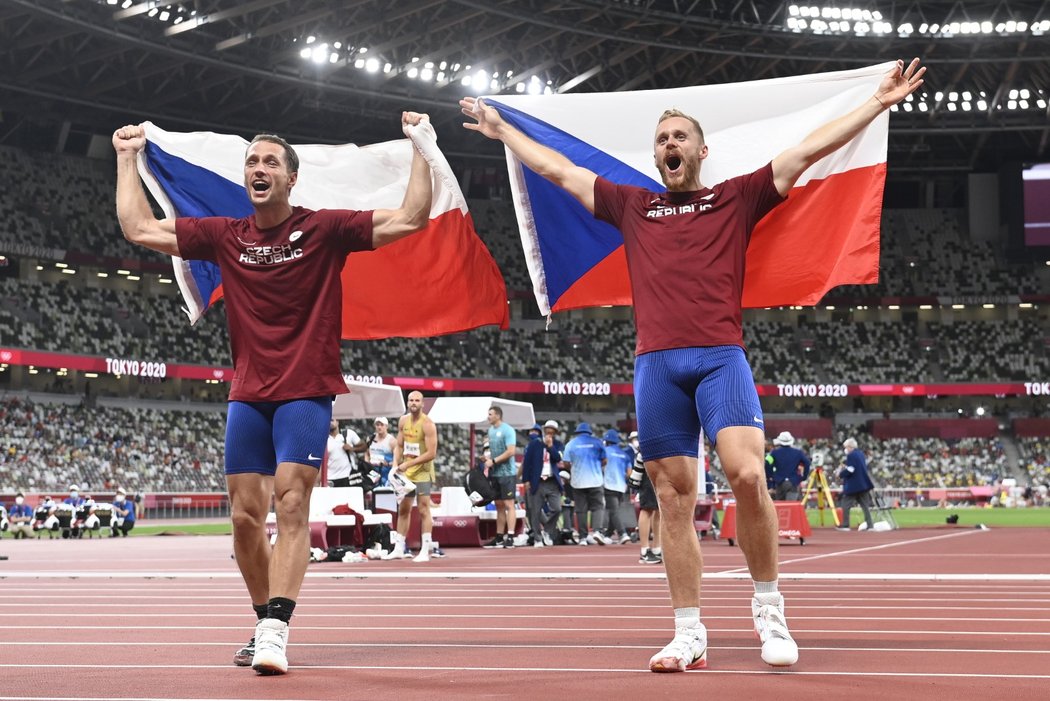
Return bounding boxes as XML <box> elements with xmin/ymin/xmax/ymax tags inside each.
<box><xmin>270</xmin><ymin>463</ymin><xmax>317</xmax><ymax>601</ymax></box>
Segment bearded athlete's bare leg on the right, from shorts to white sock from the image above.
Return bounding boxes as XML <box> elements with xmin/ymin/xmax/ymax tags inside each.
<box><xmin>715</xmin><ymin>426</ymin><xmax>778</xmax><ymax>581</ymax></box>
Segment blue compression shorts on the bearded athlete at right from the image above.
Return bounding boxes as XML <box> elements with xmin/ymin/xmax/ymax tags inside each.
<box><xmin>634</xmin><ymin>345</ymin><xmax>765</xmax><ymax>460</ymax></box>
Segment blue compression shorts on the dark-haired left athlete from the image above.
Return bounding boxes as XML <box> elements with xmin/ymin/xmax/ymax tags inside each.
<box><xmin>226</xmin><ymin>397</ymin><xmax>332</xmax><ymax>475</ymax></box>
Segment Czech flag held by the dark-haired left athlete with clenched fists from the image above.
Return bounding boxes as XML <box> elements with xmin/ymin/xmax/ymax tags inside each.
<box><xmin>139</xmin><ymin>122</ymin><xmax>508</xmax><ymax>340</ymax></box>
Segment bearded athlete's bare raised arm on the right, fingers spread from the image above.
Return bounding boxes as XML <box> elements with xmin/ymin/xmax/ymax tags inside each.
<box><xmin>773</xmin><ymin>59</ymin><xmax>926</xmax><ymax>196</ymax></box>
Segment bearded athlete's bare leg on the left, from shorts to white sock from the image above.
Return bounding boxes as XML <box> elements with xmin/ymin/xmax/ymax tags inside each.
<box><xmin>643</xmin><ymin>455</ymin><xmax>704</xmax><ymax>609</ymax></box>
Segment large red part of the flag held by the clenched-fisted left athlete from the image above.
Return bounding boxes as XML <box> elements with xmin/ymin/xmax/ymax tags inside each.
<box><xmin>342</xmin><ymin>209</ymin><xmax>509</xmax><ymax>340</ymax></box>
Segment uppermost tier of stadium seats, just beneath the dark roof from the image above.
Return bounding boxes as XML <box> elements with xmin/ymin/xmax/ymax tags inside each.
<box><xmin>0</xmin><ymin>146</ymin><xmax>1047</xmax><ymax>300</ymax></box>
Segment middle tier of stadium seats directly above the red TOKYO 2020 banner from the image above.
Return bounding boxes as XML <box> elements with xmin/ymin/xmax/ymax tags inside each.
<box><xmin>0</xmin><ymin>276</ymin><xmax>1050</xmax><ymax>383</ymax></box>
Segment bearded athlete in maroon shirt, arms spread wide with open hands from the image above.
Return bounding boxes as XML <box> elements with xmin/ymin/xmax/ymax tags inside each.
<box><xmin>460</xmin><ymin>59</ymin><xmax>926</xmax><ymax>672</ymax></box>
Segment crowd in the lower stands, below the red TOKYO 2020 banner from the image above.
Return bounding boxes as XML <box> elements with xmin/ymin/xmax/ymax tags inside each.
<box><xmin>0</xmin><ymin>398</ymin><xmax>1024</xmax><ymax>493</ymax></box>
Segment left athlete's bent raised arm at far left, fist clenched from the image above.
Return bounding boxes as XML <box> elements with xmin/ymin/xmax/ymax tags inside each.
<box><xmin>113</xmin><ymin>124</ymin><xmax>179</xmax><ymax>256</ymax></box>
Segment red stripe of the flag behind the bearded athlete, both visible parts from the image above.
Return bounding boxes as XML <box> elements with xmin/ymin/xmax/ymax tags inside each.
<box><xmin>551</xmin><ymin>163</ymin><xmax>886</xmax><ymax>312</ymax></box>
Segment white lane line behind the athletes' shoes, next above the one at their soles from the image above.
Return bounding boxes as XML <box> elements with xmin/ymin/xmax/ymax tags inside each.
<box><xmin>3</xmin><ymin>640</ymin><xmax>1050</xmax><ymax>655</ymax></box>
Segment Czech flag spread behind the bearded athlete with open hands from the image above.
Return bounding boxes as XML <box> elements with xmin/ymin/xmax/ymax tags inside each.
<box><xmin>484</xmin><ymin>63</ymin><xmax>894</xmax><ymax>315</ymax></box>
